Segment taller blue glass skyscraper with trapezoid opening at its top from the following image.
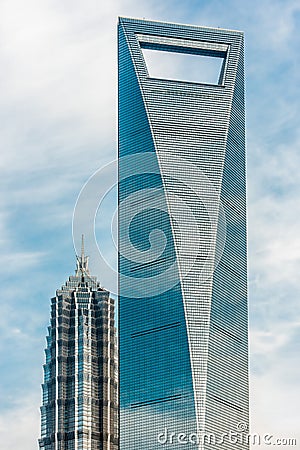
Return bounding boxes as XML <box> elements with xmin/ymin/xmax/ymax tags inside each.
<box><xmin>118</xmin><ymin>18</ymin><xmax>249</xmax><ymax>450</ymax></box>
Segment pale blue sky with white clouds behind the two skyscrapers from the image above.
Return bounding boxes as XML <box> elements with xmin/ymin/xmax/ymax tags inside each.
<box><xmin>0</xmin><ymin>0</ymin><xmax>300</xmax><ymax>450</ymax></box>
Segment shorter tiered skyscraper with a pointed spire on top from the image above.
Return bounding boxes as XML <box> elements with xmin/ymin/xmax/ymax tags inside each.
<box><xmin>39</xmin><ymin>237</ymin><xmax>118</xmax><ymax>450</ymax></box>
